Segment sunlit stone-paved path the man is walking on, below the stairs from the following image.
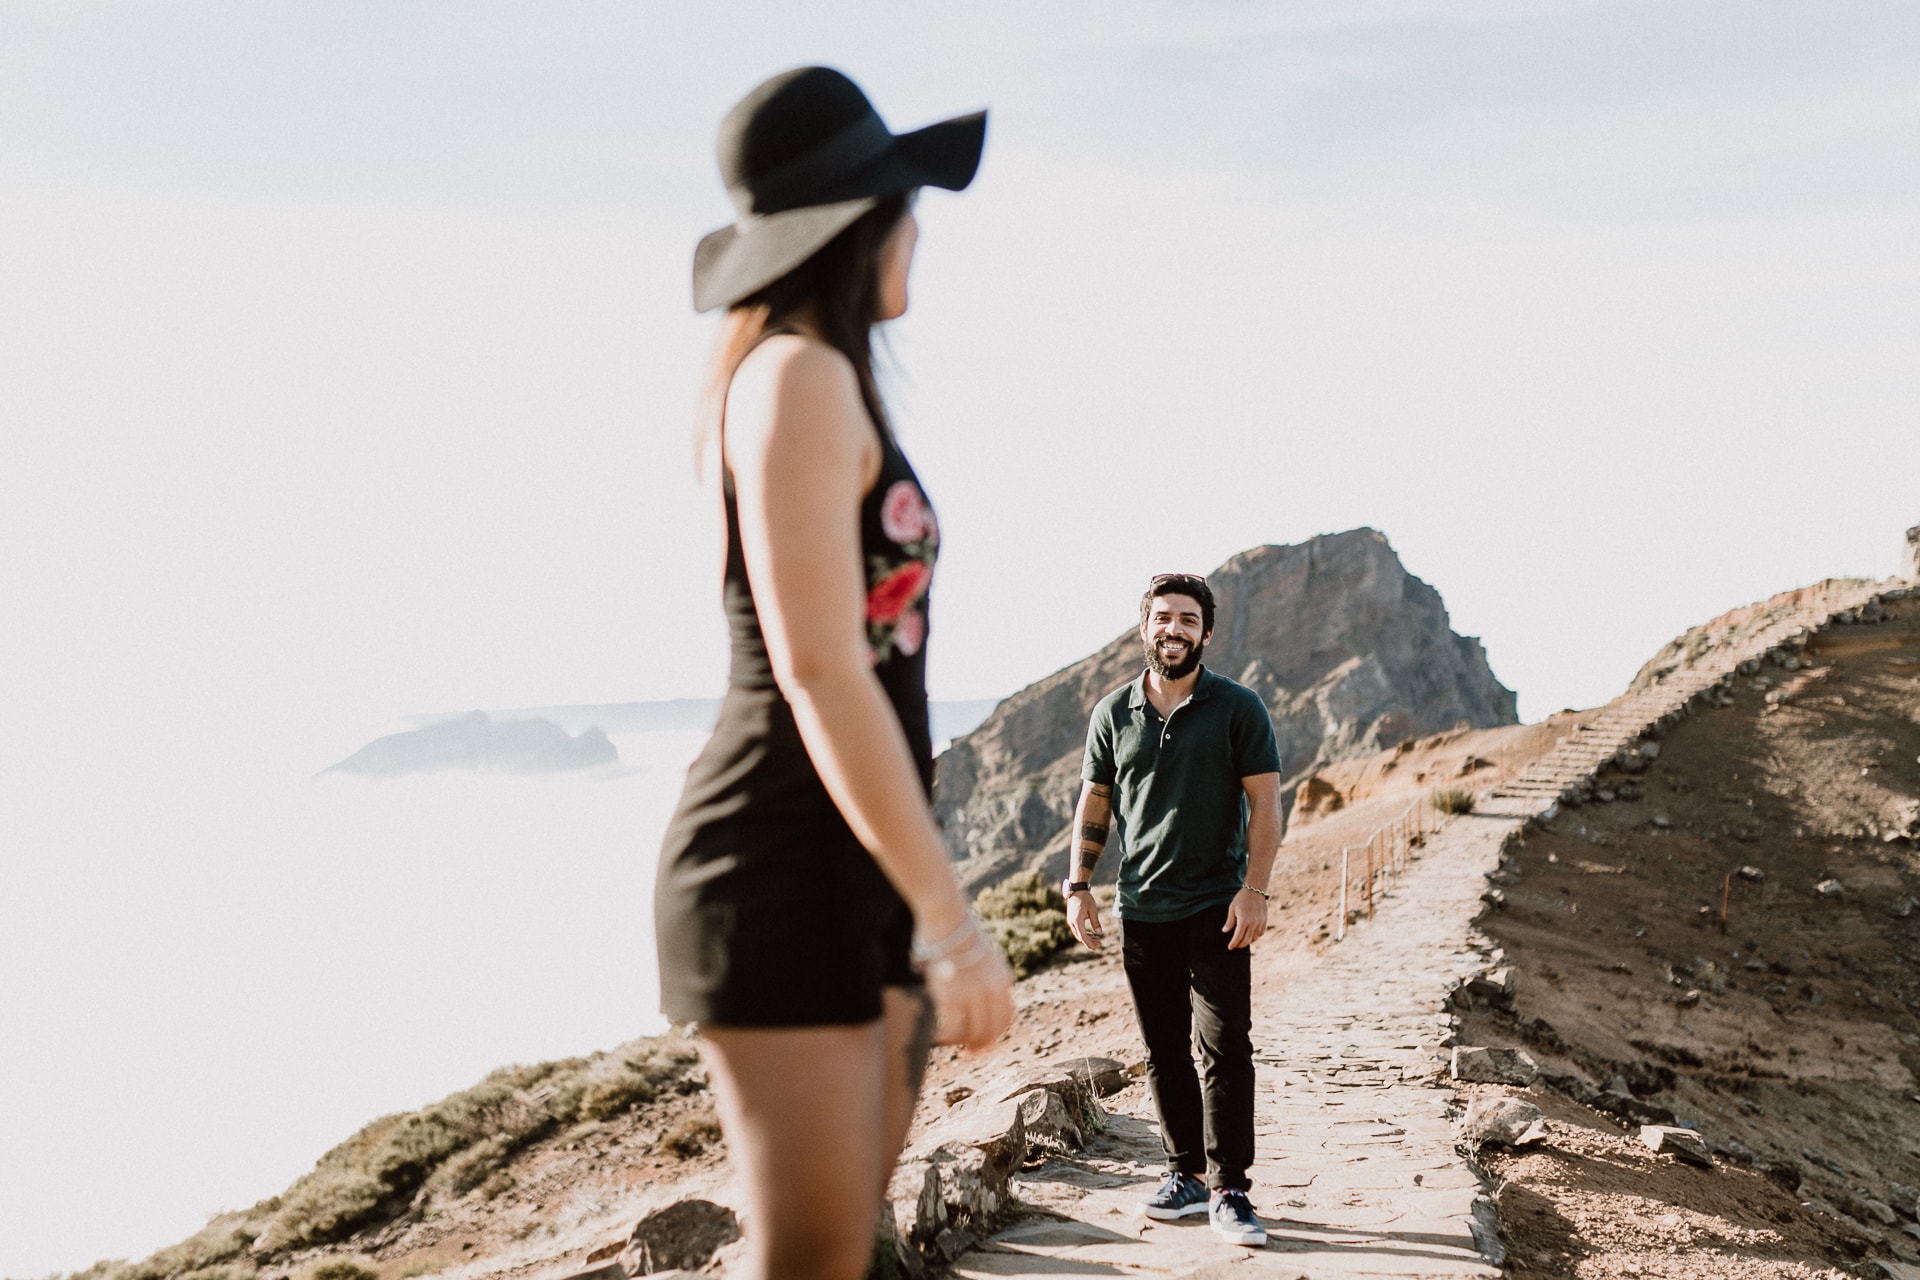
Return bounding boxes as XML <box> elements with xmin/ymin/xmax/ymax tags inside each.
<box><xmin>954</xmin><ymin>806</ymin><xmax>1526</xmax><ymax>1280</ymax></box>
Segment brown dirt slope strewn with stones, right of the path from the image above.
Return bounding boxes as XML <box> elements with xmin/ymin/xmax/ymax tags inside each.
<box><xmin>1461</xmin><ymin>601</ymin><xmax>1920</xmax><ymax>1276</ymax></box>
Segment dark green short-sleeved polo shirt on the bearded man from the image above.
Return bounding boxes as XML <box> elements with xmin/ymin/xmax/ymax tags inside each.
<box><xmin>1075</xmin><ymin>666</ymin><xmax>1281</xmax><ymax>921</ymax></box>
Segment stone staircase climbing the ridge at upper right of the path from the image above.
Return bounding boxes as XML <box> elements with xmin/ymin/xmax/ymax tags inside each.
<box><xmin>1490</xmin><ymin>580</ymin><xmax>1891</xmax><ymax>812</ymax></box>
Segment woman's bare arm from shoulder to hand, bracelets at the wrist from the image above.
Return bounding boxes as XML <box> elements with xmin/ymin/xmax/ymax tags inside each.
<box><xmin>724</xmin><ymin>336</ymin><xmax>1012</xmax><ymax>1044</ymax></box>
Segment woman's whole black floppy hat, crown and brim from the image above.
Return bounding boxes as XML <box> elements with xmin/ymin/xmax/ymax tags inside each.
<box><xmin>693</xmin><ymin>67</ymin><xmax>987</xmax><ymax>311</ymax></box>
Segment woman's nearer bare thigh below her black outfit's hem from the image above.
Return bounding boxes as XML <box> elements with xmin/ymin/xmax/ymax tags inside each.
<box><xmin>701</xmin><ymin>1017</ymin><xmax>900</xmax><ymax>1280</ymax></box>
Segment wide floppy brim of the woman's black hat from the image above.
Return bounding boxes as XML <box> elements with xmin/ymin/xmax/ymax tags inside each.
<box><xmin>693</xmin><ymin>111</ymin><xmax>987</xmax><ymax>311</ymax></box>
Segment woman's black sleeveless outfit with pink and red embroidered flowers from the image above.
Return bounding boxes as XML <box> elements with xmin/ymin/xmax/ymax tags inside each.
<box><xmin>653</xmin><ymin>385</ymin><xmax>939</xmax><ymax>1027</ymax></box>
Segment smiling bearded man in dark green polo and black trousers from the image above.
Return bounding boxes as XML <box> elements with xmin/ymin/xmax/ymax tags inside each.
<box><xmin>1062</xmin><ymin>574</ymin><xmax>1281</xmax><ymax>1245</ymax></box>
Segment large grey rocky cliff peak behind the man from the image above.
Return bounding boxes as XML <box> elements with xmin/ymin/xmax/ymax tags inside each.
<box><xmin>933</xmin><ymin>530</ymin><xmax>1515</xmax><ymax>889</ymax></box>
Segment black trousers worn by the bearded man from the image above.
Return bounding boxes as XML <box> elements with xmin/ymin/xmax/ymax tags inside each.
<box><xmin>1121</xmin><ymin>902</ymin><xmax>1254</xmax><ymax>1192</ymax></box>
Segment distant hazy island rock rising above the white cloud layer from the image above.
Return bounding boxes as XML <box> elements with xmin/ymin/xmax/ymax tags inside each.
<box><xmin>323</xmin><ymin>712</ymin><xmax>620</xmax><ymax>777</ymax></box>
